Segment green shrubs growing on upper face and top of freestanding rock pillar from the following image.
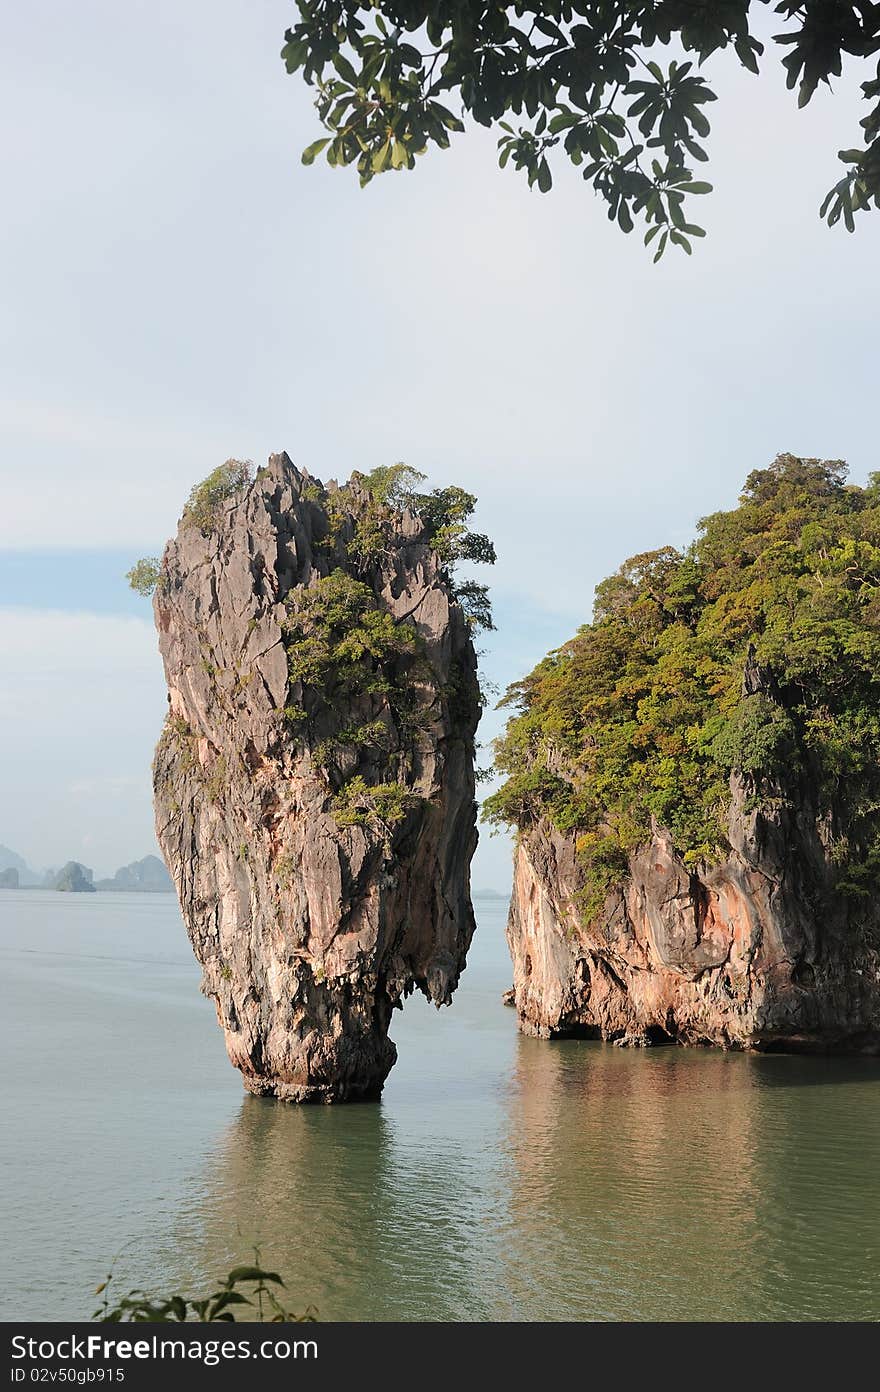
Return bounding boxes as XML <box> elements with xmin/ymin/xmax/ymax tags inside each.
<box><xmin>284</xmin><ymin>464</ymin><xmax>494</xmax><ymax>812</ymax></box>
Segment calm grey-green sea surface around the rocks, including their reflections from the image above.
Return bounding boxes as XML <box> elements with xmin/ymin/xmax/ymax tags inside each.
<box><xmin>0</xmin><ymin>891</ymin><xmax>880</xmax><ymax>1320</ymax></box>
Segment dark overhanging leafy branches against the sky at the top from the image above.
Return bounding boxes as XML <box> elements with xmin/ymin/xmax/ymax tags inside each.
<box><xmin>281</xmin><ymin>0</ymin><xmax>880</xmax><ymax>259</ymax></box>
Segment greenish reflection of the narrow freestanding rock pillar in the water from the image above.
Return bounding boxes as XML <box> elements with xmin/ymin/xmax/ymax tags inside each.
<box><xmin>189</xmin><ymin>1098</ymin><xmax>515</xmax><ymax>1320</ymax></box>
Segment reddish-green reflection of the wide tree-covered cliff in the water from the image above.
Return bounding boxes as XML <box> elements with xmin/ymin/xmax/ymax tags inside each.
<box><xmin>498</xmin><ymin>1038</ymin><xmax>880</xmax><ymax>1320</ymax></box>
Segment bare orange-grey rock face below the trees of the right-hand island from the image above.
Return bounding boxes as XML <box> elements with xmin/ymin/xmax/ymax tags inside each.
<box><xmin>507</xmin><ymin>777</ymin><xmax>880</xmax><ymax>1052</ymax></box>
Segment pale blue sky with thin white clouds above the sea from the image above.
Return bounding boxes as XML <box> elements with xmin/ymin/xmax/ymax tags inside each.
<box><xmin>0</xmin><ymin>0</ymin><xmax>880</xmax><ymax>891</ymax></box>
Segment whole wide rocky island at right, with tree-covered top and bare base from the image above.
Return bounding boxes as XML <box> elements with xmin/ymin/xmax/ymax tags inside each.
<box><xmin>486</xmin><ymin>455</ymin><xmax>880</xmax><ymax>1051</ymax></box>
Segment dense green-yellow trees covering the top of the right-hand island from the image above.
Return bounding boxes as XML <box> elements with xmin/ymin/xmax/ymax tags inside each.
<box><xmin>485</xmin><ymin>455</ymin><xmax>880</xmax><ymax>908</ymax></box>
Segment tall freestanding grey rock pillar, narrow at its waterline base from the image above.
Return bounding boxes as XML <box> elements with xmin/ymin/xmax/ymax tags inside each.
<box><xmin>155</xmin><ymin>455</ymin><xmax>479</xmax><ymax>1101</ymax></box>
